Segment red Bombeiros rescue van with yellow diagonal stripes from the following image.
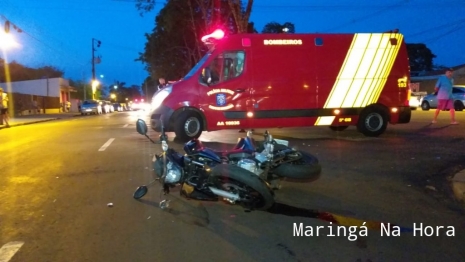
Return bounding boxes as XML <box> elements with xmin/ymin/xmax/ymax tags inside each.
<box><xmin>151</xmin><ymin>31</ymin><xmax>411</xmax><ymax>140</ymax></box>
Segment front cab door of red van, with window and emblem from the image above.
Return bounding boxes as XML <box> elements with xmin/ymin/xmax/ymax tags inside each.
<box><xmin>200</xmin><ymin>50</ymin><xmax>252</xmax><ymax>130</ymax></box>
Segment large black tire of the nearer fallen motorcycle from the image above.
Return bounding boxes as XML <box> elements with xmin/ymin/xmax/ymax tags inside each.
<box><xmin>209</xmin><ymin>164</ymin><xmax>274</xmax><ymax>210</ymax></box>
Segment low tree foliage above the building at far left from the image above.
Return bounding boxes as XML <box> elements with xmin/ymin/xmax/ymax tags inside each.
<box><xmin>0</xmin><ymin>58</ymin><xmax>63</xmax><ymax>82</ymax></box>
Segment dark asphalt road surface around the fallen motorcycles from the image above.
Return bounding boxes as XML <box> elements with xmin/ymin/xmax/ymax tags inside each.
<box><xmin>0</xmin><ymin>111</ymin><xmax>465</xmax><ymax>262</ymax></box>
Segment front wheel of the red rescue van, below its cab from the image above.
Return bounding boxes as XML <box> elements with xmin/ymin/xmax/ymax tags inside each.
<box><xmin>174</xmin><ymin>111</ymin><xmax>203</xmax><ymax>141</ymax></box>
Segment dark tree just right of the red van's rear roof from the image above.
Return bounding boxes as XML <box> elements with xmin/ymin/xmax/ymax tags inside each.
<box><xmin>407</xmin><ymin>44</ymin><xmax>436</xmax><ymax>71</ymax></box>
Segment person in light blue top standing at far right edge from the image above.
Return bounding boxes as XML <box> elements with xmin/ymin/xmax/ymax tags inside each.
<box><xmin>432</xmin><ymin>68</ymin><xmax>458</xmax><ymax>125</ymax></box>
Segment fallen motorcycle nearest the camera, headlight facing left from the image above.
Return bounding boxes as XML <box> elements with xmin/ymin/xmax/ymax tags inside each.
<box><xmin>133</xmin><ymin>119</ymin><xmax>274</xmax><ymax>210</ymax></box>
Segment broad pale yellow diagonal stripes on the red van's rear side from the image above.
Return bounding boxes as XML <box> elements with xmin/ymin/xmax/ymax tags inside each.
<box><xmin>315</xmin><ymin>34</ymin><xmax>403</xmax><ymax>125</ymax></box>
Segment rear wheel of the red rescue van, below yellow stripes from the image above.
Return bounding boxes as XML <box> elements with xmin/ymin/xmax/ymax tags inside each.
<box><xmin>357</xmin><ymin>107</ymin><xmax>387</xmax><ymax>137</ymax></box>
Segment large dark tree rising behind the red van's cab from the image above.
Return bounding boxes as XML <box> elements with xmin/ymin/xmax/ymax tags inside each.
<box><xmin>136</xmin><ymin>0</ymin><xmax>256</xmax><ymax>87</ymax></box>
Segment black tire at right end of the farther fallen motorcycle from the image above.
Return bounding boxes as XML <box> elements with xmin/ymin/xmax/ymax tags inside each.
<box><xmin>271</xmin><ymin>151</ymin><xmax>321</xmax><ymax>180</ymax></box>
